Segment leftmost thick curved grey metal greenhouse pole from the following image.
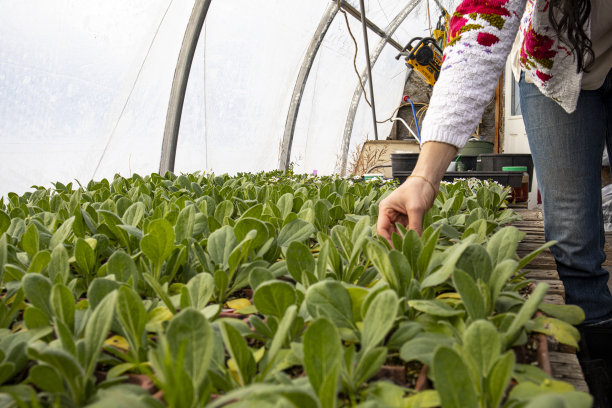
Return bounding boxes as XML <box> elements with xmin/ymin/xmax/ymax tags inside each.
<box><xmin>159</xmin><ymin>0</ymin><xmax>212</xmax><ymax>174</ymax></box>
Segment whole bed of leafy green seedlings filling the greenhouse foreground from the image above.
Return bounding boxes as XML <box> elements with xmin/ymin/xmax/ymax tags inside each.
<box><xmin>0</xmin><ymin>172</ymin><xmax>589</xmax><ymax>407</ymax></box>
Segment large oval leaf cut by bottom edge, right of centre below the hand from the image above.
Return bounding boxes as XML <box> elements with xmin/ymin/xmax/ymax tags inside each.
<box><xmin>432</xmin><ymin>346</ymin><xmax>478</xmax><ymax>408</ymax></box>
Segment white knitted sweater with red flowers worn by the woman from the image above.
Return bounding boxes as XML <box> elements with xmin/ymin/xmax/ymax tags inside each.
<box><xmin>421</xmin><ymin>0</ymin><xmax>590</xmax><ymax>148</ymax></box>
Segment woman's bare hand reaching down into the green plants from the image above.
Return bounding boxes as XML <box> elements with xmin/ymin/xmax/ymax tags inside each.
<box><xmin>376</xmin><ymin>177</ymin><xmax>438</xmax><ymax>243</ymax></box>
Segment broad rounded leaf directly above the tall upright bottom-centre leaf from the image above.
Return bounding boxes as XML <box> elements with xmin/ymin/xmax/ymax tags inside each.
<box><xmin>305</xmin><ymin>280</ymin><xmax>355</xmax><ymax>329</ymax></box>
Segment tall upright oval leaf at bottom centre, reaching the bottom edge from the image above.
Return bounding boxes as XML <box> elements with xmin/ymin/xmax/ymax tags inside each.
<box><xmin>303</xmin><ymin>318</ymin><xmax>342</xmax><ymax>408</ymax></box>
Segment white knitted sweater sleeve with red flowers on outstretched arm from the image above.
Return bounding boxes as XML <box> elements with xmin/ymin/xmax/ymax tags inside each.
<box><xmin>421</xmin><ymin>0</ymin><xmax>526</xmax><ymax>148</ymax></box>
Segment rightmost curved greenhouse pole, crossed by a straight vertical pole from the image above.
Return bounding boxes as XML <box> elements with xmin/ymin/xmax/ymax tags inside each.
<box><xmin>339</xmin><ymin>0</ymin><xmax>421</xmax><ymax>174</ymax></box>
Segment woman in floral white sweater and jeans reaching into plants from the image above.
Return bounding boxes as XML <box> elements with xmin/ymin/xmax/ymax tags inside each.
<box><xmin>377</xmin><ymin>0</ymin><xmax>612</xmax><ymax>398</ymax></box>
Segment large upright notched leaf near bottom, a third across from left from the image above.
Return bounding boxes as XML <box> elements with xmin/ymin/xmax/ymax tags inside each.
<box><xmin>166</xmin><ymin>308</ymin><xmax>214</xmax><ymax>390</ymax></box>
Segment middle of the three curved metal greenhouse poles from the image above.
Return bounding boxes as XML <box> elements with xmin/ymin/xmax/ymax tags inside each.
<box><xmin>278</xmin><ymin>2</ymin><xmax>338</xmax><ymax>170</ymax></box>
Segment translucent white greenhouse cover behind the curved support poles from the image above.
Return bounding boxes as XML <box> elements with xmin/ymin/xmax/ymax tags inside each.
<box><xmin>0</xmin><ymin>0</ymin><xmax>454</xmax><ymax>195</ymax></box>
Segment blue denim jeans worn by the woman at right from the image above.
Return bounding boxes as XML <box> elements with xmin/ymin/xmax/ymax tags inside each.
<box><xmin>519</xmin><ymin>71</ymin><xmax>612</xmax><ymax>324</ymax></box>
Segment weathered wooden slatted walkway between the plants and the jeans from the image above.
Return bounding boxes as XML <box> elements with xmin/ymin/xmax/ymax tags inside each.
<box><xmin>513</xmin><ymin>207</ymin><xmax>592</xmax><ymax>392</ymax></box>
